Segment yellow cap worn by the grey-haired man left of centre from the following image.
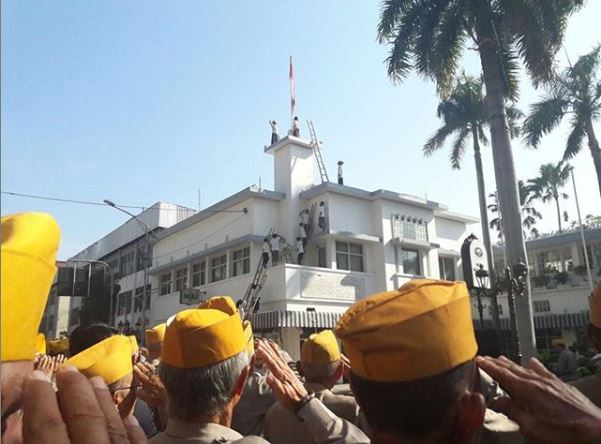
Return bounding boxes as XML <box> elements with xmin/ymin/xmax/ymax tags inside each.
<box><xmin>163</xmin><ymin>296</ymin><xmax>247</xmax><ymax>368</ymax></box>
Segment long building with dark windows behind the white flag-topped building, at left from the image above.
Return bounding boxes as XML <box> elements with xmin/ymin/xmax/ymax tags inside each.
<box><xmin>41</xmin><ymin>202</ymin><xmax>194</xmax><ymax>338</ymax></box>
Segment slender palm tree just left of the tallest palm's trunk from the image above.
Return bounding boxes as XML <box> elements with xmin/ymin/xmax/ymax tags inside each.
<box><xmin>423</xmin><ymin>74</ymin><xmax>522</xmax><ymax>281</ymax></box>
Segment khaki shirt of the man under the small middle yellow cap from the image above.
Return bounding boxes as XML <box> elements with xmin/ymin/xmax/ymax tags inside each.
<box><xmin>264</xmin><ymin>383</ymin><xmax>359</xmax><ymax>444</ymax></box>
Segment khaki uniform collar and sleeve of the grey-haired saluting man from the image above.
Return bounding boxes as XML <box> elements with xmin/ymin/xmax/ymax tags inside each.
<box><xmin>149</xmin><ymin>399</ymin><xmax>369</xmax><ymax>444</ymax></box>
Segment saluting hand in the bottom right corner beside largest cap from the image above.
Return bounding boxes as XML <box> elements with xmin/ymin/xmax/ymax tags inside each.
<box><xmin>476</xmin><ymin>356</ymin><xmax>601</xmax><ymax>444</ymax></box>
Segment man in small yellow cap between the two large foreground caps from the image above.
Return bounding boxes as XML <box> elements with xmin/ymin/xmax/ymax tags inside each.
<box><xmin>265</xmin><ymin>330</ymin><xmax>359</xmax><ymax>444</ymax></box>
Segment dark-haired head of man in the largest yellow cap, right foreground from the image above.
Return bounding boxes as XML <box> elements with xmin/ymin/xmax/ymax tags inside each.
<box><xmin>336</xmin><ymin>279</ymin><xmax>524</xmax><ymax>443</ymax></box>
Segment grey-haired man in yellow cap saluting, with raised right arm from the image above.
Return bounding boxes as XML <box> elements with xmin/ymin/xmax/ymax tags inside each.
<box><xmin>150</xmin><ymin>296</ymin><xmax>367</xmax><ymax>444</ymax></box>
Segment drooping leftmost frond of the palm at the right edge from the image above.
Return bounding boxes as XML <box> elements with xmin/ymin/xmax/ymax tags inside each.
<box><xmin>522</xmin><ymin>96</ymin><xmax>569</xmax><ymax>148</ymax></box>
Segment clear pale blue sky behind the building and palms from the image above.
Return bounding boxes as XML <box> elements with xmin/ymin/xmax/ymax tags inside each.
<box><xmin>1</xmin><ymin>0</ymin><xmax>601</xmax><ymax>259</ymax></box>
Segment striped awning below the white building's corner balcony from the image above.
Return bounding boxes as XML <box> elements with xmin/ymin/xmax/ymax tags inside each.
<box><xmin>251</xmin><ymin>310</ymin><xmax>342</xmax><ymax>330</ymax></box>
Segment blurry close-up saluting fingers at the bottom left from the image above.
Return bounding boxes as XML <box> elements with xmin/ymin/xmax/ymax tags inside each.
<box><xmin>23</xmin><ymin>366</ymin><xmax>146</xmax><ymax>444</ymax></box>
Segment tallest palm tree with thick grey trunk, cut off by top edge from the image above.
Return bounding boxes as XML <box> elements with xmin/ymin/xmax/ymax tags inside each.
<box><xmin>378</xmin><ymin>0</ymin><xmax>583</xmax><ymax>360</ymax></box>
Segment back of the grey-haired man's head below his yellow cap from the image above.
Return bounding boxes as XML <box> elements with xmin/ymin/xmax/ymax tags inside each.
<box><xmin>159</xmin><ymin>351</ymin><xmax>249</xmax><ymax>418</ymax></box>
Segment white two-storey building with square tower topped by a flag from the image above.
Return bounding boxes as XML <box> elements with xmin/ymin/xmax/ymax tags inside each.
<box><xmin>145</xmin><ymin>136</ymin><xmax>478</xmax><ymax>357</ymax></box>
